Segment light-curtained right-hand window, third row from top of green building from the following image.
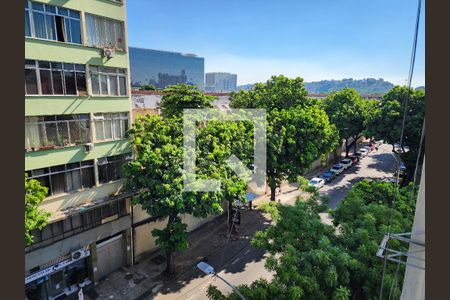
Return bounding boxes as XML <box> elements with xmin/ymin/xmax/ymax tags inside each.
<box><xmin>94</xmin><ymin>113</ymin><xmax>128</xmax><ymax>141</ymax></box>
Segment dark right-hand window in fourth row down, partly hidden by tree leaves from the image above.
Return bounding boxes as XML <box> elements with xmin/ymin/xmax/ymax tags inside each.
<box><xmin>98</xmin><ymin>154</ymin><xmax>131</xmax><ymax>183</ymax></box>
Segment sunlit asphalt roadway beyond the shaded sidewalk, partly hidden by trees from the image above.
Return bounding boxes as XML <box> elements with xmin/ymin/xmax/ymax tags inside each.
<box><xmin>148</xmin><ymin>144</ymin><xmax>395</xmax><ymax>300</ymax></box>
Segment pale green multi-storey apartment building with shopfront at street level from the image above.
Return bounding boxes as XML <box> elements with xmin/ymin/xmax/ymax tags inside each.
<box><xmin>24</xmin><ymin>0</ymin><xmax>132</xmax><ymax>299</ymax></box>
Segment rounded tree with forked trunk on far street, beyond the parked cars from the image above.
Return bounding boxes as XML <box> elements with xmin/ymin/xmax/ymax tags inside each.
<box><xmin>324</xmin><ymin>88</ymin><xmax>368</xmax><ymax>156</ymax></box>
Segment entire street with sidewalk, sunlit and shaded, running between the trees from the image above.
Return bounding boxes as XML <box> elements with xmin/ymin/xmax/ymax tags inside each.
<box><xmin>89</xmin><ymin>144</ymin><xmax>395</xmax><ymax>300</ymax></box>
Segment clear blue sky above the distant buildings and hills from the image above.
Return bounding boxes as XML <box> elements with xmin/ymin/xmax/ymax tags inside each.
<box><xmin>127</xmin><ymin>0</ymin><xmax>425</xmax><ymax>86</ymax></box>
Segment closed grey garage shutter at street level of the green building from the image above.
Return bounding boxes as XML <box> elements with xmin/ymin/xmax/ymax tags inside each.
<box><xmin>97</xmin><ymin>235</ymin><xmax>124</xmax><ymax>278</ymax></box>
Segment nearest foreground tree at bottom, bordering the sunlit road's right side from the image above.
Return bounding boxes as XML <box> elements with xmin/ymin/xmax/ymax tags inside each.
<box><xmin>208</xmin><ymin>201</ymin><xmax>356</xmax><ymax>300</ymax></box>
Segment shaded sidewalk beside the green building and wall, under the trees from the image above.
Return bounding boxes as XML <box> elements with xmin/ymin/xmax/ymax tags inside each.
<box><xmin>85</xmin><ymin>184</ymin><xmax>306</xmax><ymax>300</ymax></box>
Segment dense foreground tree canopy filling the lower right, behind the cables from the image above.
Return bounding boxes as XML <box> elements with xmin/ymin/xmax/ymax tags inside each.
<box><xmin>208</xmin><ymin>180</ymin><xmax>415</xmax><ymax>300</ymax></box>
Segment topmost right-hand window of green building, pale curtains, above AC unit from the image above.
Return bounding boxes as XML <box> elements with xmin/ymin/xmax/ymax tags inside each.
<box><xmin>85</xmin><ymin>13</ymin><xmax>125</xmax><ymax>50</ymax></box>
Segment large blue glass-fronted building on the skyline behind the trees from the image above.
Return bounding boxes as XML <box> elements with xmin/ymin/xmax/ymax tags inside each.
<box><xmin>129</xmin><ymin>47</ymin><xmax>205</xmax><ymax>90</ymax></box>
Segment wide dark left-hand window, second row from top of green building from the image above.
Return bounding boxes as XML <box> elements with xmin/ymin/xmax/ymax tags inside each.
<box><xmin>25</xmin><ymin>59</ymin><xmax>87</xmax><ymax>95</ymax></box>
